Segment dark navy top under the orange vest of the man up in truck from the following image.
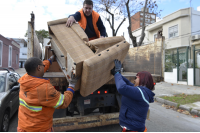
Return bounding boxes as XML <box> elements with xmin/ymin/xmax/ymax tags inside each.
<box><xmin>70</xmin><ymin>12</ymin><xmax>106</xmax><ymax>38</ymax></box>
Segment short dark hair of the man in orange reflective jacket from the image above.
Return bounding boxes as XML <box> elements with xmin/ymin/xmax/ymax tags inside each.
<box><xmin>24</xmin><ymin>57</ymin><xmax>42</xmax><ymax>75</ymax></box>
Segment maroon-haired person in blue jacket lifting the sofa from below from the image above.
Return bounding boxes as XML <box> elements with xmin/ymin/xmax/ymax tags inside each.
<box><xmin>111</xmin><ymin>59</ymin><xmax>155</xmax><ymax>132</ymax></box>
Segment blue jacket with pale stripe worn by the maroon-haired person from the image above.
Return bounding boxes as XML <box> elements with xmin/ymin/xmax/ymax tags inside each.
<box><xmin>115</xmin><ymin>73</ymin><xmax>155</xmax><ymax>132</ymax></box>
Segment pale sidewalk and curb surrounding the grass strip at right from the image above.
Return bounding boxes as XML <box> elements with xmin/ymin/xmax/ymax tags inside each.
<box><xmin>154</xmin><ymin>82</ymin><xmax>200</xmax><ymax>117</ymax></box>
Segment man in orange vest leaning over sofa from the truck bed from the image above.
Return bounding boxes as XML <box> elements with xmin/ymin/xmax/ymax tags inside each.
<box><xmin>66</xmin><ymin>0</ymin><xmax>106</xmax><ymax>40</ymax></box>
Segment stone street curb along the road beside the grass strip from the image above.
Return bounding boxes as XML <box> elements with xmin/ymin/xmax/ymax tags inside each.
<box><xmin>154</xmin><ymin>97</ymin><xmax>200</xmax><ymax>117</ymax></box>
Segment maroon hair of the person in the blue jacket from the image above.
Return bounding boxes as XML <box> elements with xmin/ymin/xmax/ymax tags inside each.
<box><xmin>136</xmin><ymin>71</ymin><xmax>154</xmax><ymax>90</ymax></box>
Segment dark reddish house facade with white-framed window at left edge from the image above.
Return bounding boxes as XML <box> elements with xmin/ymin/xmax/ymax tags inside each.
<box><xmin>0</xmin><ymin>34</ymin><xmax>20</xmax><ymax>69</ymax></box>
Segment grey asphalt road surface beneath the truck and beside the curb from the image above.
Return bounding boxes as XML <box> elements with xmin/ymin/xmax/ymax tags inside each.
<box><xmin>9</xmin><ymin>102</ymin><xmax>200</xmax><ymax>132</ymax></box>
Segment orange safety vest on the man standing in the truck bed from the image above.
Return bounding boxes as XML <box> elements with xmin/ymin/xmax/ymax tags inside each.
<box><xmin>78</xmin><ymin>9</ymin><xmax>100</xmax><ymax>38</ymax></box>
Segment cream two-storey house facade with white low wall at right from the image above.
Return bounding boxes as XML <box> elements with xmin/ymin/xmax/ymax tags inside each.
<box><xmin>133</xmin><ymin>8</ymin><xmax>200</xmax><ymax>85</ymax></box>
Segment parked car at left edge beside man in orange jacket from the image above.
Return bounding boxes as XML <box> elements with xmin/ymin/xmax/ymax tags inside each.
<box><xmin>0</xmin><ymin>68</ymin><xmax>20</xmax><ymax>132</ymax></box>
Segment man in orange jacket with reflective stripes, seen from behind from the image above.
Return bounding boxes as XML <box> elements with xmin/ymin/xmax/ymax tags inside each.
<box><xmin>17</xmin><ymin>55</ymin><xmax>78</xmax><ymax>132</ymax></box>
